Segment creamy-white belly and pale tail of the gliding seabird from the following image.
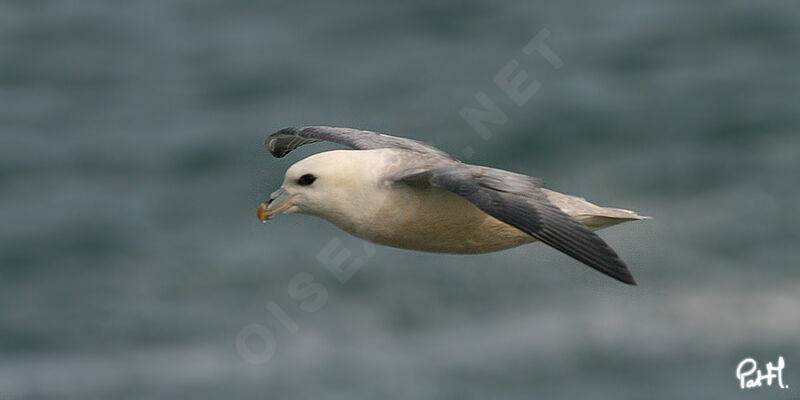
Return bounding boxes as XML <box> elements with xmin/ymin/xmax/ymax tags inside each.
<box><xmin>320</xmin><ymin>180</ymin><xmax>641</xmax><ymax>254</ymax></box>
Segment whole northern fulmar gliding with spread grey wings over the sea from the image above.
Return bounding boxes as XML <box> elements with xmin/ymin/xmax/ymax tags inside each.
<box><xmin>258</xmin><ymin>126</ymin><xmax>648</xmax><ymax>285</ymax></box>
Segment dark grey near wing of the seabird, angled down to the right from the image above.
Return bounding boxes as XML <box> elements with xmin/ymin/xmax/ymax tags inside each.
<box><xmin>394</xmin><ymin>164</ymin><xmax>636</xmax><ymax>285</ymax></box>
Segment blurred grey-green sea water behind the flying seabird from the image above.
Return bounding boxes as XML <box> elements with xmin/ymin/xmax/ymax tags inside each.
<box><xmin>0</xmin><ymin>0</ymin><xmax>800</xmax><ymax>399</ymax></box>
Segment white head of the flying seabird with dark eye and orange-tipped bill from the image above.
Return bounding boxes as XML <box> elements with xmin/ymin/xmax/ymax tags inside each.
<box><xmin>258</xmin><ymin>150</ymin><xmax>379</xmax><ymax>222</ymax></box>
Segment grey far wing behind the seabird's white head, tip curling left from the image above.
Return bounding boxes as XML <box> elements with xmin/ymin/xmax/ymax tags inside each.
<box><xmin>266</xmin><ymin>126</ymin><xmax>452</xmax><ymax>159</ymax></box>
